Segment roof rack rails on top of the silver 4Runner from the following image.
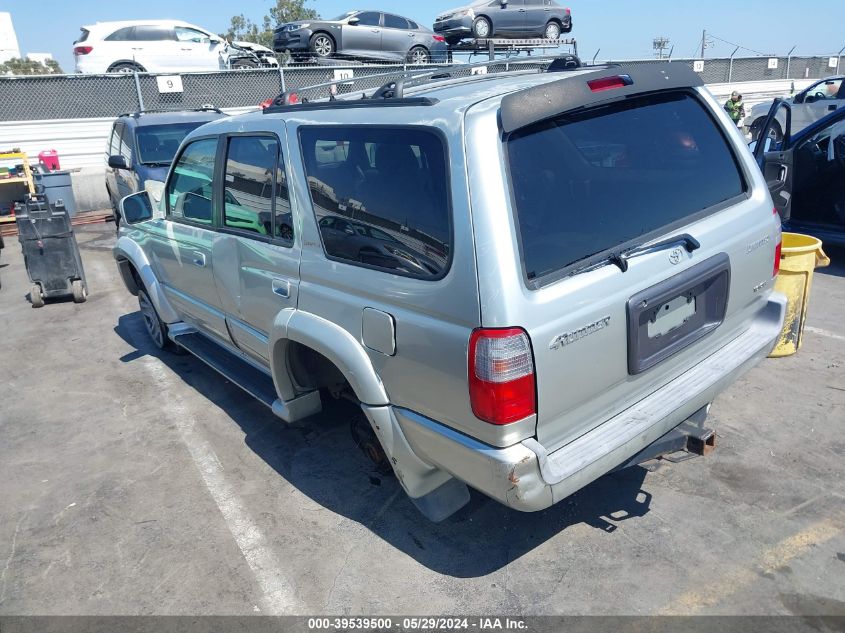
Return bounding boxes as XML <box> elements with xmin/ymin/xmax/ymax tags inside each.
<box><xmin>264</xmin><ymin>54</ymin><xmax>588</xmax><ymax>114</ymax></box>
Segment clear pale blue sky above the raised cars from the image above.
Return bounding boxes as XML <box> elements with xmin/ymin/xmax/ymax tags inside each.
<box><xmin>0</xmin><ymin>0</ymin><xmax>845</xmax><ymax>72</ymax></box>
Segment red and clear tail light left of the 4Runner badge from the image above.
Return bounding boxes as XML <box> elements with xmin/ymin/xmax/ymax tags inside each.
<box><xmin>468</xmin><ymin>328</ymin><xmax>537</xmax><ymax>425</ymax></box>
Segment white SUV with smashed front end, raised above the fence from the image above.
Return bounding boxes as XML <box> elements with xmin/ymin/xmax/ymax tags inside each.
<box><xmin>73</xmin><ymin>20</ymin><xmax>278</xmax><ymax>73</ymax></box>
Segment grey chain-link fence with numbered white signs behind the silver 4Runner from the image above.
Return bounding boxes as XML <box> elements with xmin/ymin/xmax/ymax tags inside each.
<box><xmin>0</xmin><ymin>56</ymin><xmax>845</xmax><ymax>121</ymax></box>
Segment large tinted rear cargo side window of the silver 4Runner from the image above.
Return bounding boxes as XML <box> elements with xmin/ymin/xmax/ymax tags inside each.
<box><xmin>300</xmin><ymin>126</ymin><xmax>452</xmax><ymax>279</ymax></box>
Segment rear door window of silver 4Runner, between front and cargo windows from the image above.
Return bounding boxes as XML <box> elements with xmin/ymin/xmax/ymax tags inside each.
<box><xmin>223</xmin><ymin>136</ymin><xmax>293</xmax><ymax>239</ymax></box>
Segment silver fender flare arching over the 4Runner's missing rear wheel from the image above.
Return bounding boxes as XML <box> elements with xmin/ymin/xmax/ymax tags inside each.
<box><xmin>270</xmin><ymin>310</ymin><xmax>390</xmax><ymax>406</ymax></box>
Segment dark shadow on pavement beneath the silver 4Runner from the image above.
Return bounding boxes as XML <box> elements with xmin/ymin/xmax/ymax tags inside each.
<box><xmin>115</xmin><ymin>312</ymin><xmax>651</xmax><ymax>578</ymax></box>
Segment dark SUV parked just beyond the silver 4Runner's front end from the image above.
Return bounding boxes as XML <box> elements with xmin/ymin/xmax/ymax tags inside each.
<box><xmin>106</xmin><ymin>107</ymin><xmax>226</xmax><ymax>227</ymax></box>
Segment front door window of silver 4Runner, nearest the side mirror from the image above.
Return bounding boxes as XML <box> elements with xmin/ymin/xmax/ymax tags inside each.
<box><xmin>166</xmin><ymin>138</ymin><xmax>217</xmax><ymax>225</ymax></box>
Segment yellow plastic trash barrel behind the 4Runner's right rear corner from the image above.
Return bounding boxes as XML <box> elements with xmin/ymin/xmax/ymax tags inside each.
<box><xmin>769</xmin><ymin>233</ymin><xmax>830</xmax><ymax>358</ymax></box>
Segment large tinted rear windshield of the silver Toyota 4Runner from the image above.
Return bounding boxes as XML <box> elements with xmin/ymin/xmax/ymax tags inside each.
<box><xmin>507</xmin><ymin>93</ymin><xmax>745</xmax><ymax>282</ymax></box>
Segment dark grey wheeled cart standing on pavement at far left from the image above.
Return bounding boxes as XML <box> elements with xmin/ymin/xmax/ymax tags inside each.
<box><xmin>15</xmin><ymin>194</ymin><xmax>88</xmax><ymax>308</ymax></box>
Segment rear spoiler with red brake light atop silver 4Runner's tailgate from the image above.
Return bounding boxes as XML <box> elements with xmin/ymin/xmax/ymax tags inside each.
<box><xmin>500</xmin><ymin>62</ymin><xmax>704</xmax><ymax>134</ymax></box>
